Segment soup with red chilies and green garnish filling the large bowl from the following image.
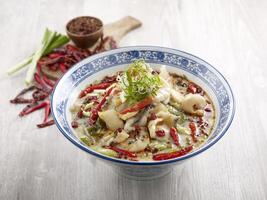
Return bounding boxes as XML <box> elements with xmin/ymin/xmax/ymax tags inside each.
<box><xmin>71</xmin><ymin>60</ymin><xmax>215</xmax><ymax>161</ymax></box>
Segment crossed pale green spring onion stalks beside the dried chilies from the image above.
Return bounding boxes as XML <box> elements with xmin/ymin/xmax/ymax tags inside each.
<box><xmin>7</xmin><ymin>29</ymin><xmax>69</xmax><ymax>84</ymax></box>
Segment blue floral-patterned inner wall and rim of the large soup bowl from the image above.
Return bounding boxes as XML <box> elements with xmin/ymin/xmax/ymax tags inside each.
<box><xmin>51</xmin><ymin>46</ymin><xmax>235</xmax><ymax>166</ymax></box>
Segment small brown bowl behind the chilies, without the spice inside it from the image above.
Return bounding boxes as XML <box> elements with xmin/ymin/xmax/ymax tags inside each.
<box><xmin>66</xmin><ymin>16</ymin><xmax>103</xmax><ymax>49</ymax></box>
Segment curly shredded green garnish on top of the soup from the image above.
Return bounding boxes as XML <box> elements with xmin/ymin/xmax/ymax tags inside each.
<box><xmin>120</xmin><ymin>59</ymin><xmax>163</xmax><ymax>104</ymax></box>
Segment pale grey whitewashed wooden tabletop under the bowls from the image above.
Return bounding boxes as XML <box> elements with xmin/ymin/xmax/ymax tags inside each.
<box><xmin>0</xmin><ymin>0</ymin><xmax>267</xmax><ymax>200</ymax></box>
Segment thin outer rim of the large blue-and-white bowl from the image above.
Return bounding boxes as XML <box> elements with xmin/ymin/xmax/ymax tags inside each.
<box><xmin>50</xmin><ymin>45</ymin><xmax>236</xmax><ymax>166</ymax></box>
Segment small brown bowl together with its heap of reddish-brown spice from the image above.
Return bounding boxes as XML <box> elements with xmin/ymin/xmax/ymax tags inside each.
<box><xmin>66</xmin><ymin>16</ymin><xmax>103</xmax><ymax>48</ymax></box>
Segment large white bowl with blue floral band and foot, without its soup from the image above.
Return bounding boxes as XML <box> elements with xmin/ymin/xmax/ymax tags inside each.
<box><xmin>51</xmin><ymin>46</ymin><xmax>235</xmax><ymax>179</ymax></box>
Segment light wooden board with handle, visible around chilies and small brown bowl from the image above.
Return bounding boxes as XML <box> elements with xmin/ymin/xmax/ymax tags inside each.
<box><xmin>42</xmin><ymin>16</ymin><xmax>142</xmax><ymax>80</ymax></box>
